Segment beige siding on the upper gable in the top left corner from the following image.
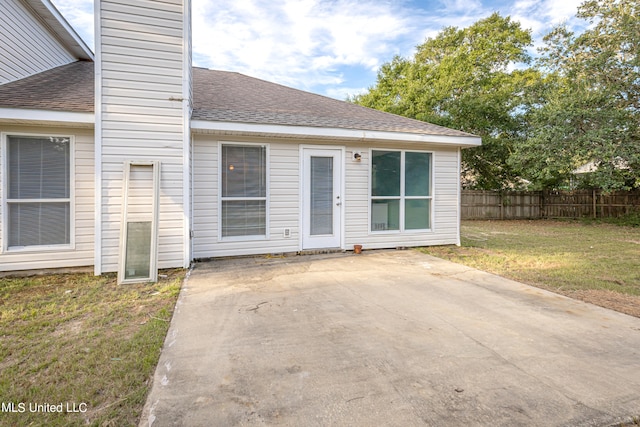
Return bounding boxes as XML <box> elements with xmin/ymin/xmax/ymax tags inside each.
<box><xmin>0</xmin><ymin>0</ymin><xmax>76</xmax><ymax>84</ymax></box>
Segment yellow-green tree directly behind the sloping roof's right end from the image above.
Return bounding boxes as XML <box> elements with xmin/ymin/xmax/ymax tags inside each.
<box><xmin>353</xmin><ymin>13</ymin><xmax>539</xmax><ymax>189</ymax></box>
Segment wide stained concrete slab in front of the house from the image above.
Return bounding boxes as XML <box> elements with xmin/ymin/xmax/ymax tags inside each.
<box><xmin>141</xmin><ymin>251</ymin><xmax>640</xmax><ymax>427</ymax></box>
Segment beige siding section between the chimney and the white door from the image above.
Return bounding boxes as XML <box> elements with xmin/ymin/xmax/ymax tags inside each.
<box><xmin>193</xmin><ymin>135</ymin><xmax>300</xmax><ymax>258</ymax></box>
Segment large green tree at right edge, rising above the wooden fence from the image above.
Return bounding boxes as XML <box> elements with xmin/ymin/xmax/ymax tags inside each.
<box><xmin>509</xmin><ymin>0</ymin><xmax>640</xmax><ymax>190</ymax></box>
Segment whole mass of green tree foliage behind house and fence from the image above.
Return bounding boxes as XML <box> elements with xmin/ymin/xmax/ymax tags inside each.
<box><xmin>353</xmin><ymin>0</ymin><xmax>640</xmax><ymax>189</ymax></box>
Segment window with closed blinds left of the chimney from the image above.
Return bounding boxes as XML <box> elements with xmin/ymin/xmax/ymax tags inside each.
<box><xmin>5</xmin><ymin>135</ymin><xmax>72</xmax><ymax>249</ymax></box>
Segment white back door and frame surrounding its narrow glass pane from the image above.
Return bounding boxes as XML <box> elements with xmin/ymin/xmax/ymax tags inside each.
<box><xmin>300</xmin><ymin>145</ymin><xmax>345</xmax><ymax>250</ymax></box>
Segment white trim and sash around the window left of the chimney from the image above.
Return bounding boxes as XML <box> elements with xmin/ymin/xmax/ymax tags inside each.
<box><xmin>0</xmin><ymin>132</ymin><xmax>76</xmax><ymax>253</ymax></box>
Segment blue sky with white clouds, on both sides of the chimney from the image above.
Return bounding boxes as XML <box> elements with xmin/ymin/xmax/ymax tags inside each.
<box><xmin>52</xmin><ymin>0</ymin><xmax>583</xmax><ymax>99</ymax></box>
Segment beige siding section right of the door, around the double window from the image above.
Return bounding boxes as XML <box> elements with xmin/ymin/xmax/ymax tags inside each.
<box><xmin>345</xmin><ymin>143</ymin><xmax>460</xmax><ymax>249</ymax></box>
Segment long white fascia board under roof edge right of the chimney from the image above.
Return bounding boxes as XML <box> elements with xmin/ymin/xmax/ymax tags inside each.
<box><xmin>191</xmin><ymin>120</ymin><xmax>482</xmax><ymax>147</ymax></box>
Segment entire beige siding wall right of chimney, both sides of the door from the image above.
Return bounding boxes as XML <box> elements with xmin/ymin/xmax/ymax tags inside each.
<box><xmin>193</xmin><ymin>135</ymin><xmax>460</xmax><ymax>258</ymax></box>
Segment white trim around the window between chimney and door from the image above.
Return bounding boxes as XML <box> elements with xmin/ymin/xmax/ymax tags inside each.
<box><xmin>217</xmin><ymin>141</ymin><xmax>271</xmax><ymax>243</ymax></box>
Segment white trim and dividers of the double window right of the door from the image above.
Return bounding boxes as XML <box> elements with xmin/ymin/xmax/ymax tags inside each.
<box><xmin>367</xmin><ymin>147</ymin><xmax>435</xmax><ymax>236</ymax></box>
